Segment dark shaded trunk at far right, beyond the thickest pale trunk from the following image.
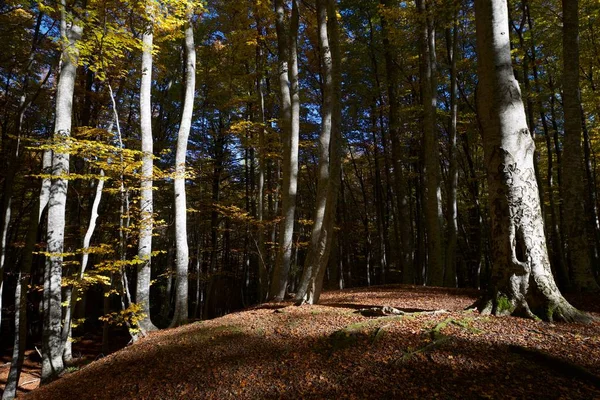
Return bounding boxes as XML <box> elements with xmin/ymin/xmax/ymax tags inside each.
<box><xmin>561</xmin><ymin>0</ymin><xmax>600</xmax><ymax>291</ymax></box>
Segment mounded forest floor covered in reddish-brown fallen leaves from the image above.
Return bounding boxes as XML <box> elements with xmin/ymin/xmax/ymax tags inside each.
<box><xmin>0</xmin><ymin>285</ymin><xmax>600</xmax><ymax>400</ymax></box>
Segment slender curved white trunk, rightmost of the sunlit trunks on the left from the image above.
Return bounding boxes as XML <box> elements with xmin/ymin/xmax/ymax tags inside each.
<box><xmin>171</xmin><ymin>16</ymin><xmax>196</xmax><ymax>326</ymax></box>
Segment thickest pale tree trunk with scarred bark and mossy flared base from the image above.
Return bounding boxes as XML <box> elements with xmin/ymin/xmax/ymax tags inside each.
<box><xmin>475</xmin><ymin>0</ymin><xmax>586</xmax><ymax>321</ymax></box>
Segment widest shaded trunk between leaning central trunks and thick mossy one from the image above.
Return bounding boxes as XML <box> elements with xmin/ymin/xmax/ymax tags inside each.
<box><xmin>416</xmin><ymin>0</ymin><xmax>444</xmax><ymax>286</ymax></box>
